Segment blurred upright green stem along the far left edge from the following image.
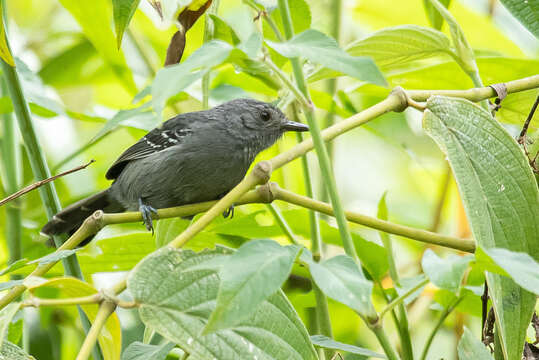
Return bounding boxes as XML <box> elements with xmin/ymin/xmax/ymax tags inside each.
<box><xmin>0</xmin><ymin>78</ymin><xmax>22</xmax><ymax>280</ymax></box>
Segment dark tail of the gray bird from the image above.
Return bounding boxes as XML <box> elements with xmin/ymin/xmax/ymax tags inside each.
<box><xmin>41</xmin><ymin>189</ymin><xmax>125</xmax><ymax>245</ymax></box>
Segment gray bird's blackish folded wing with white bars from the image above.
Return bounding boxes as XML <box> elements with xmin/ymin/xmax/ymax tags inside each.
<box><xmin>105</xmin><ymin>115</ymin><xmax>192</xmax><ymax>180</ymax></box>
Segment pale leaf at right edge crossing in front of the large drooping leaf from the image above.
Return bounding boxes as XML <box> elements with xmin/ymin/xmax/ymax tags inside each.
<box><xmin>476</xmin><ymin>247</ymin><xmax>539</xmax><ymax>295</ymax></box>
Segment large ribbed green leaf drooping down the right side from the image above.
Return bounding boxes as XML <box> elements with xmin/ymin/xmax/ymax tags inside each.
<box><xmin>423</xmin><ymin>96</ymin><xmax>539</xmax><ymax>360</ymax></box>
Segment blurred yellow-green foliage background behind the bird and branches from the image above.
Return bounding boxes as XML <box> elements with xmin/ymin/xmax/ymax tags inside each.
<box><xmin>0</xmin><ymin>0</ymin><xmax>539</xmax><ymax>360</ymax></box>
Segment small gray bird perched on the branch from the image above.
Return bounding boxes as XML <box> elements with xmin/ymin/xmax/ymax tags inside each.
<box><xmin>41</xmin><ymin>99</ymin><xmax>309</xmax><ymax>245</ymax></box>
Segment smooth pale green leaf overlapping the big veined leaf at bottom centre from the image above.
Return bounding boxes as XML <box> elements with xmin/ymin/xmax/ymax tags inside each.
<box><xmin>203</xmin><ymin>240</ymin><xmax>300</xmax><ymax>334</ymax></box>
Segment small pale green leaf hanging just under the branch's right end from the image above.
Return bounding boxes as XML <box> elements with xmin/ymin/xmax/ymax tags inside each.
<box><xmin>421</xmin><ymin>249</ymin><xmax>472</xmax><ymax>292</ymax></box>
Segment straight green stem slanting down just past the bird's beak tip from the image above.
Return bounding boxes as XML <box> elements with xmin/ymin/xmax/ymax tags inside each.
<box><xmin>278</xmin><ymin>0</ymin><xmax>360</xmax><ymax>265</ymax></box>
